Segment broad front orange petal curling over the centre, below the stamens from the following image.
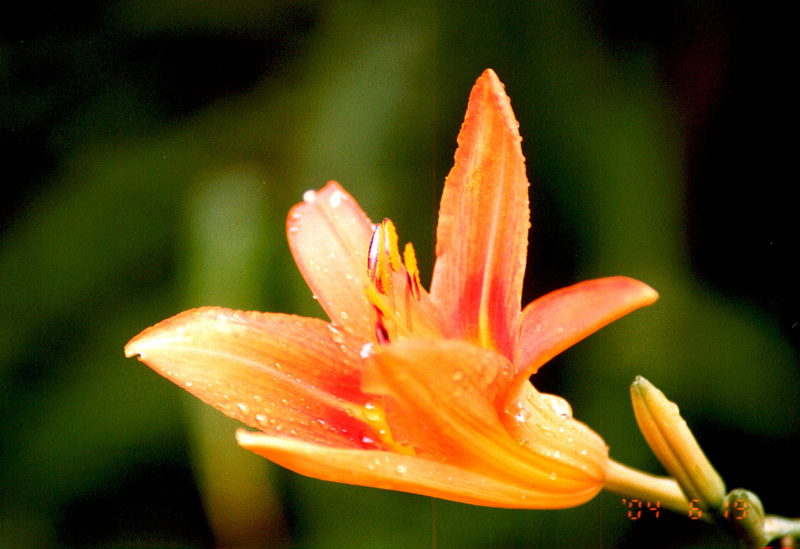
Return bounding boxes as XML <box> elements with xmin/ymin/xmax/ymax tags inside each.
<box><xmin>362</xmin><ymin>340</ymin><xmax>605</xmax><ymax>505</ymax></box>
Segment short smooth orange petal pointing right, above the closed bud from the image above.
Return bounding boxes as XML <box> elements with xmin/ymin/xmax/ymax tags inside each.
<box><xmin>515</xmin><ymin>276</ymin><xmax>658</xmax><ymax>378</ymax></box>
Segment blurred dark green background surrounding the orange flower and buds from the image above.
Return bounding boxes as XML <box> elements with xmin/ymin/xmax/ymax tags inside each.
<box><xmin>0</xmin><ymin>0</ymin><xmax>800</xmax><ymax>547</ymax></box>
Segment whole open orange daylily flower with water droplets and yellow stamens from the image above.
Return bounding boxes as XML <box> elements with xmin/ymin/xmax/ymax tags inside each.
<box><xmin>125</xmin><ymin>70</ymin><xmax>657</xmax><ymax>509</ymax></box>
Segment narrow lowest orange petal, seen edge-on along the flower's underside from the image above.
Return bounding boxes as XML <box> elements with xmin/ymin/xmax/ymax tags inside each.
<box><xmin>236</xmin><ymin>430</ymin><xmax>596</xmax><ymax>509</ymax></box>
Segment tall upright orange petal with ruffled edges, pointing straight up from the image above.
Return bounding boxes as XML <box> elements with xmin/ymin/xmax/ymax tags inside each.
<box><xmin>431</xmin><ymin>69</ymin><xmax>530</xmax><ymax>360</ymax></box>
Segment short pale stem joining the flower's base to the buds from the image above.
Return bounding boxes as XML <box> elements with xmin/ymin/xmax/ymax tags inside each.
<box><xmin>603</xmin><ymin>459</ymin><xmax>711</xmax><ymax>522</ymax></box>
